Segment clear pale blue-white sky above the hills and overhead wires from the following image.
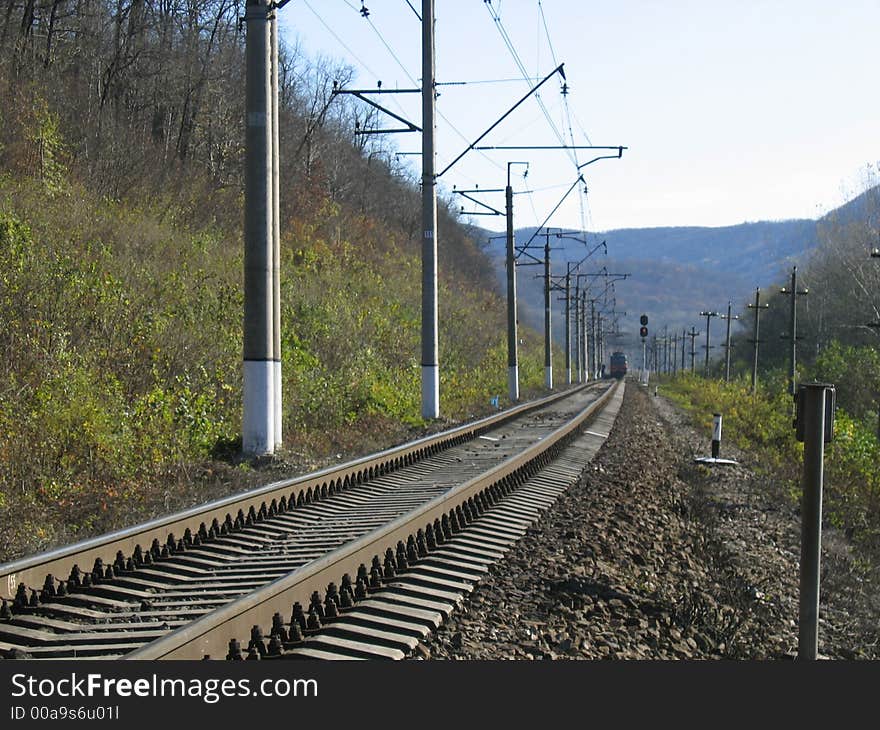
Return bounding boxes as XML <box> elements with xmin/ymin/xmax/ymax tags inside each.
<box><xmin>281</xmin><ymin>0</ymin><xmax>880</xmax><ymax>231</ymax></box>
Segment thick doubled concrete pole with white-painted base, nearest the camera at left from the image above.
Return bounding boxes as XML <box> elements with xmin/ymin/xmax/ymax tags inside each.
<box><xmin>241</xmin><ymin>0</ymin><xmax>275</xmax><ymax>455</ymax></box>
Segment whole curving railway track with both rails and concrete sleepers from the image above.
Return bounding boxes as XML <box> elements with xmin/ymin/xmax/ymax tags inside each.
<box><xmin>0</xmin><ymin>384</ymin><xmax>622</xmax><ymax>659</ymax></box>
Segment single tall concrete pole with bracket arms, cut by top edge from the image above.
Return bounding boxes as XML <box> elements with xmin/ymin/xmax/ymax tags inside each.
<box><xmin>422</xmin><ymin>0</ymin><xmax>440</xmax><ymax>418</ymax></box>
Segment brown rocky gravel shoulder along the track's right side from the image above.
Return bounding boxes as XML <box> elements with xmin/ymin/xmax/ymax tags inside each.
<box><xmin>419</xmin><ymin>383</ymin><xmax>880</xmax><ymax>659</ymax></box>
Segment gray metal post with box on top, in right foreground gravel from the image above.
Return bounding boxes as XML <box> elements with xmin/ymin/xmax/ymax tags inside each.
<box><xmin>798</xmin><ymin>383</ymin><xmax>828</xmax><ymax>659</ymax></box>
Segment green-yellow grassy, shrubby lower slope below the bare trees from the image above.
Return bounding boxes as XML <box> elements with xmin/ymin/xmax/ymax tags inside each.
<box><xmin>0</xmin><ymin>177</ymin><xmax>542</xmax><ymax>561</ymax></box>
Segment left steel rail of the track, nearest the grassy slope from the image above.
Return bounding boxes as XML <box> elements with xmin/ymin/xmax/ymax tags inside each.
<box><xmin>0</xmin><ymin>385</ymin><xmax>589</xmax><ymax>600</ymax></box>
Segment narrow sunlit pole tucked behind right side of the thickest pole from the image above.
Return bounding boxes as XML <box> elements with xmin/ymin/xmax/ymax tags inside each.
<box><xmin>269</xmin><ymin>10</ymin><xmax>284</xmax><ymax>448</ymax></box>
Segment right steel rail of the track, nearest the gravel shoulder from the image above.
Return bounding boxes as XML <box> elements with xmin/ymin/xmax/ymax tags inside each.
<box><xmin>124</xmin><ymin>382</ymin><xmax>620</xmax><ymax>660</ymax></box>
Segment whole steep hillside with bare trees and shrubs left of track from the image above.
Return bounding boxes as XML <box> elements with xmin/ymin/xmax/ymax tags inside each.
<box><xmin>0</xmin><ymin>0</ymin><xmax>541</xmax><ymax>562</ymax></box>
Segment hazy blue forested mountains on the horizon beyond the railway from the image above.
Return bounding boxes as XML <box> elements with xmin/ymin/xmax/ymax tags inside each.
<box><xmin>474</xmin><ymin>188</ymin><xmax>880</xmax><ymax>357</ymax></box>
